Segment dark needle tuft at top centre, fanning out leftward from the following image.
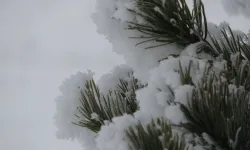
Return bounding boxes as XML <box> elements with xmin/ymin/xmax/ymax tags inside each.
<box><xmin>129</xmin><ymin>0</ymin><xmax>208</xmax><ymax>47</ymax></box>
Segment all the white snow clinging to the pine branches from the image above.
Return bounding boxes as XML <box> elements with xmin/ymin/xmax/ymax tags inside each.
<box><xmin>55</xmin><ymin>0</ymin><xmax>245</xmax><ymax>150</ymax></box>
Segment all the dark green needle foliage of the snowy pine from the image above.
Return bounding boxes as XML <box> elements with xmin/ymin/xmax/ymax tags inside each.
<box><xmin>66</xmin><ymin>0</ymin><xmax>250</xmax><ymax>150</ymax></box>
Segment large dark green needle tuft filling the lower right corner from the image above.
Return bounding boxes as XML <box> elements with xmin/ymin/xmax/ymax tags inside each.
<box><xmin>181</xmin><ymin>72</ymin><xmax>250</xmax><ymax>150</ymax></box>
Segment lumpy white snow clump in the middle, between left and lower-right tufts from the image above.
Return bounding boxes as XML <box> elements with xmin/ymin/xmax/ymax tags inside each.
<box><xmin>136</xmin><ymin>56</ymin><xmax>206</xmax><ymax>123</ymax></box>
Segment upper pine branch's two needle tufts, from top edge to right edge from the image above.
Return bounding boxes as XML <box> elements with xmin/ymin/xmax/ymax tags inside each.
<box><xmin>128</xmin><ymin>0</ymin><xmax>250</xmax><ymax>62</ymax></box>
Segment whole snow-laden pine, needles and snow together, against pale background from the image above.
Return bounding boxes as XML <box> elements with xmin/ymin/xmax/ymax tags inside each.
<box><xmin>55</xmin><ymin>0</ymin><xmax>250</xmax><ymax>150</ymax></box>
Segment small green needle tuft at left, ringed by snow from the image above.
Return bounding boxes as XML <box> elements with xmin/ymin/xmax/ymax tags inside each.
<box><xmin>73</xmin><ymin>78</ymin><xmax>142</xmax><ymax>132</ymax></box>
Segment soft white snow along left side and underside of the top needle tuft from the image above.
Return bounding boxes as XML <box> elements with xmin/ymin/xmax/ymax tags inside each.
<box><xmin>92</xmin><ymin>0</ymin><xmax>181</xmax><ymax>83</ymax></box>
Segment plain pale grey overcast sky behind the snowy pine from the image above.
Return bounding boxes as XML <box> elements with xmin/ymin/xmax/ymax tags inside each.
<box><xmin>0</xmin><ymin>0</ymin><xmax>250</xmax><ymax>150</ymax></box>
